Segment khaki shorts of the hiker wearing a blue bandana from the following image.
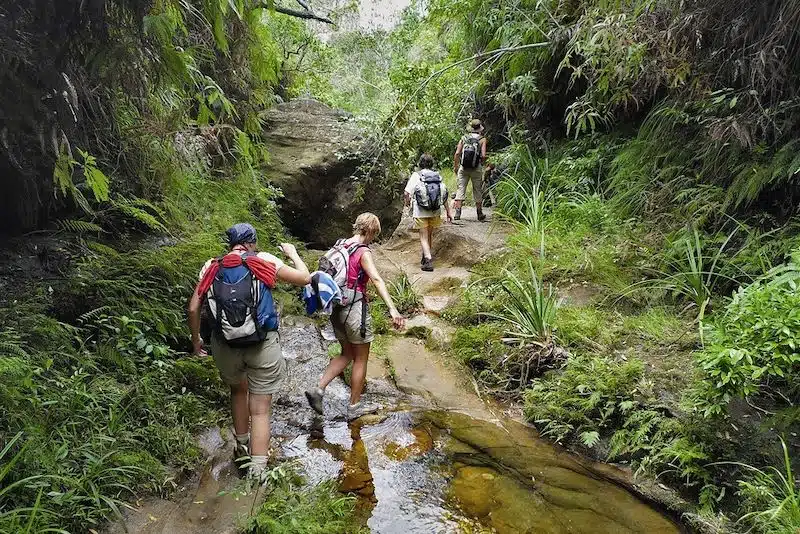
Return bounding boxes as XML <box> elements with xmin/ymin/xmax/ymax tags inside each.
<box><xmin>211</xmin><ymin>332</ymin><xmax>286</xmax><ymax>395</ymax></box>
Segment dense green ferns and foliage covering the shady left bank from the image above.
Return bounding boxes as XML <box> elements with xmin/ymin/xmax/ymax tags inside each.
<box><xmin>0</xmin><ymin>0</ymin><xmax>322</xmax><ymax>532</ymax></box>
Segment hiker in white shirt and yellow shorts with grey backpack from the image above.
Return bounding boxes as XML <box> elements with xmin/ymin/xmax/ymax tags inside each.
<box><xmin>404</xmin><ymin>154</ymin><xmax>453</xmax><ymax>272</ymax></box>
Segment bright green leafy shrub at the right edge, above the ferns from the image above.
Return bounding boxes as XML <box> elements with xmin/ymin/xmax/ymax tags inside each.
<box><xmin>696</xmin><ymin>258</ymin><xmax>800</xmax><ymax>416</ymax></box>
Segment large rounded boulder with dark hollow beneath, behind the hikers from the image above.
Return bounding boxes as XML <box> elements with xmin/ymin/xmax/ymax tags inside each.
<box><xmin>264</xmin><ymin>100</ymin><xmax>403</xmax><ymax>247</ymax></box>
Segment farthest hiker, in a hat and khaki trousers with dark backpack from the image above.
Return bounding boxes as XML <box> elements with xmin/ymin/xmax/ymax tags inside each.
<box><xmin>453</xmin><ymin>119</ymin><xmax>486</xmax><ymax>221</ymax></box>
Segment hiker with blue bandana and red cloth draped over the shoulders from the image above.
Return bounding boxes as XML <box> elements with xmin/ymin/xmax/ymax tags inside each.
<box><xmin>189</xmin><ymin>223</ymin><xmax>311</xmax><ymax>476</ymax></box>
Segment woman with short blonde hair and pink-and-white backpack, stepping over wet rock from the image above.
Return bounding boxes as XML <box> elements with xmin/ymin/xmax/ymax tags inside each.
<box><xmin>305</xmin><ymin>213</ymin><xmax>405</xmax><ymax>421</ymax></box>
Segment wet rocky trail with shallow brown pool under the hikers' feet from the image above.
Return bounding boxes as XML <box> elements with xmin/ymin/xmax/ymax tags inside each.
<box><xmin>112</xmin><ymin>210</ymin><xmax>684</xmax><ymax>534</ymax></box>
